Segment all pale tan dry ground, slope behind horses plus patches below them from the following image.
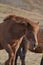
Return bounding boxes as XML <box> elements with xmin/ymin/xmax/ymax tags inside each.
<box><xmin>0</xmin><ymin>4</ymin><xmax>43</xmax><ymax>65</ymax></box>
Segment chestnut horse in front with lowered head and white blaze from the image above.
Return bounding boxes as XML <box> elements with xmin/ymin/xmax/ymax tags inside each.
<box><xmin>0</xmin><ymin>15</ymin><xmax>39</xmax><ymax>65</ymax></box>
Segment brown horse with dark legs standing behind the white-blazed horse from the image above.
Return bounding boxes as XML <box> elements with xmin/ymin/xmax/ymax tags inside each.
<box><xmin>15</xmin><ymin>28</ymin><xmax>43</xmax><ymax>65</ymax></box>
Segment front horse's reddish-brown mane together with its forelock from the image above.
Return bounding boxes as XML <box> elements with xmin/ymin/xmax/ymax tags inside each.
<box><xmin>3</xmin><ymin>15</ymin><xmax>39</xmax><ymax>29</ymax></box>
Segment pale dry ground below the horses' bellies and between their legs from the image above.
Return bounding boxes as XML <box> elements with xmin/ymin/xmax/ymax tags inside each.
<box><xmin>0</xmin><ymin>50</ymin><xmax>42</xmax><ymax>65</ymax></box>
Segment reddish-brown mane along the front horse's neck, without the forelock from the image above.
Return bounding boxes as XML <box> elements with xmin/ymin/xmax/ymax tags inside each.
<box><xmin>3</xmin><ymin>15</ymin><xmax>33</xmax><ymax>28</ymax></box>
